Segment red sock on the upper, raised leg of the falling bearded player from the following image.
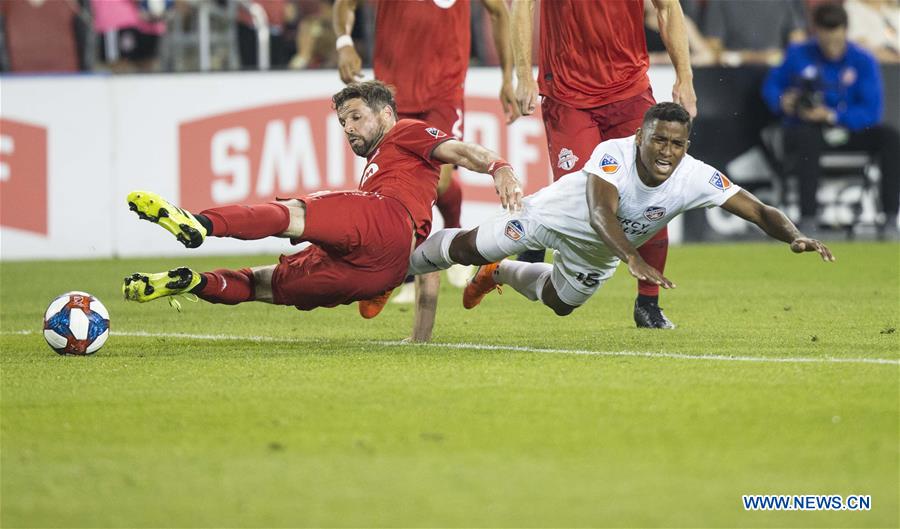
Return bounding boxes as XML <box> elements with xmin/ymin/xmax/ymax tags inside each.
<box><xmin>200</xmin><ymin>202</ymin><xmax>291</xmax><ymax>240</ymax></box>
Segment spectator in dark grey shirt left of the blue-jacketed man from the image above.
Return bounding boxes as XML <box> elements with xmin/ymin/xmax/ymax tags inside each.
<box><xmin>703</xmin><ymin>0</ymin><xmax>806</xmax><ymax>66</ymax></box>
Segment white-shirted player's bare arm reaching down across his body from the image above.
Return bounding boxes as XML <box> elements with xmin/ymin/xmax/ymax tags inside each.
<box><xmin>587</xmin><ymin>173</ymin><xmax>675</xmax><ymax>288</ymax></box>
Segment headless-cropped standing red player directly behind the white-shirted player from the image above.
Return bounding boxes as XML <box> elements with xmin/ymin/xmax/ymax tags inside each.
<box><xmin>512</xmin><ymin>0</ymin><xmax>697</xmax><ymax>329</ymax></box>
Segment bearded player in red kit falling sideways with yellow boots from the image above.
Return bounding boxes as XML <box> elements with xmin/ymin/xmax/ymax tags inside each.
<box><xmin>122</xmin><ymin>81</ymin><xmax>522</xmax><ymax>339</ymax></box>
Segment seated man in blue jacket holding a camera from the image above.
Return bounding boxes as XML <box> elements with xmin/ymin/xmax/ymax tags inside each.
<box><xmin>763</xmin><ymin>3</ymin><xmax>900</xmax><ymax>238</ymax></box>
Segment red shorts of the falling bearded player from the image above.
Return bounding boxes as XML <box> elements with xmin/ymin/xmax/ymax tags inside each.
<box><xmin>272</xmin><ymin>191</ymin><xmax>413</xmax><ymax>310</ymax></box>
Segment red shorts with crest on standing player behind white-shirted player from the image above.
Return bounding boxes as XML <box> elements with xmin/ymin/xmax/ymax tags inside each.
<box><xmin>541</xmin><ymin>84</ymin><xmax>656</xmax><ymax>180</ymax></box>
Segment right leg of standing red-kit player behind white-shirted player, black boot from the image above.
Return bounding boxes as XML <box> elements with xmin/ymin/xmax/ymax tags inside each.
<box><xmin>596</xmin><ymin>88</ymin><xmax>675</xmax><ymax>329</ymax></box>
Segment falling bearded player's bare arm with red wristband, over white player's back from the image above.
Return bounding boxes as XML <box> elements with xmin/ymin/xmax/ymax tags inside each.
<box><xmin>431</xmin><ymin>140</ymin><xmax>522</xmax><ymax>211</ymax></box>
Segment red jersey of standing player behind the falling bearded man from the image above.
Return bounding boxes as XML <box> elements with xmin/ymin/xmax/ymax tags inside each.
<box><xmin>374</xmin><ymin>0</ymin><xmax>471</xmax><ymax>114</ymax></box>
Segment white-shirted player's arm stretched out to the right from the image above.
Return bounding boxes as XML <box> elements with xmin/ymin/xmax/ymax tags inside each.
<box><xmin>722</xmin><ymin>189</ymin><xmax>834</xmax><ymax>262</ymax></box>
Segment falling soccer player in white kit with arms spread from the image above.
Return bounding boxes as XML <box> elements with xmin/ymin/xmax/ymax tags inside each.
<box><xmin>410</xmin><ymin>103</ymin><xmax>834</xmax><ymax>339</ymax></box>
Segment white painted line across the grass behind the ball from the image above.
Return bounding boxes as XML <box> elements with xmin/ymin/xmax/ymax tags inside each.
<box><xmin>2</xmin><ymin>330</ymin><xmax>900</xmax><ymax>365</ymax></box>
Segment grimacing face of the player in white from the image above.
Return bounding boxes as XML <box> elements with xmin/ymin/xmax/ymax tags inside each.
<box><xmin>635</xmin><ymin>120</ymin><xmax>691</xmax><ymax>186</ymax></box>
